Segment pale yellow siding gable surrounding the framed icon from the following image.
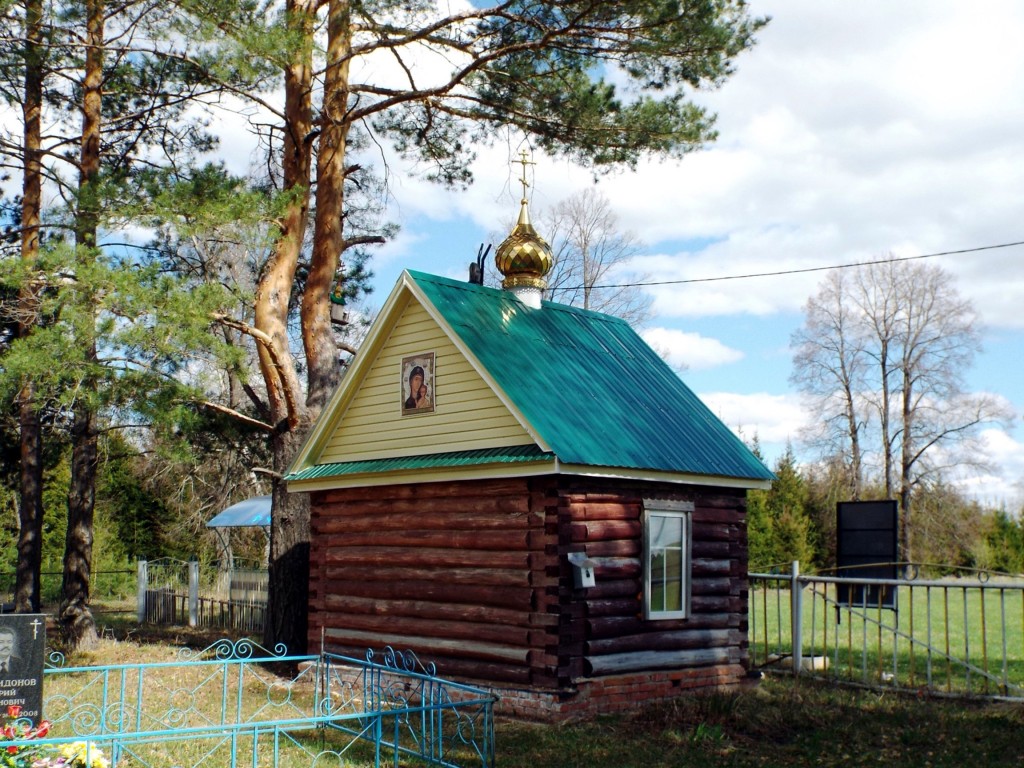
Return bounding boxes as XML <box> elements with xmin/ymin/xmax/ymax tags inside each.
<box><xmin>316</xmin><ymin>299</ymin><xmax>535</xmax><ymax>464</ymax></box>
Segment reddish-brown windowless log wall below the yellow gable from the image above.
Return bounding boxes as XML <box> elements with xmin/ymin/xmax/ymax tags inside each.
<box><xmin>309</xmin><ymin>479</ymin><xmax>558</xmax><ymax>684</ymax></box>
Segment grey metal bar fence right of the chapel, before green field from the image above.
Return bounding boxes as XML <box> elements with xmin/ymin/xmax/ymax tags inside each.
<box><xmin>749</xmin><ymin>563</ymin><xmax>1024</xmax><ymax>699</ymax></box>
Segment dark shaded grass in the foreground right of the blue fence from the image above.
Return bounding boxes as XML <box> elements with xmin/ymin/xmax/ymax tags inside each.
<box><xmin>497</xmin><ymin>677</ymin><xmax>1024</xmax><ymax>768</ymax></box>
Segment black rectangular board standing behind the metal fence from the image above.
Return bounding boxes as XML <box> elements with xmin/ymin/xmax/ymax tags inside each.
<box><xmin>836</xmin><ymin>500</ymin><xmax>899</xmax><ymax>610</ymax></box>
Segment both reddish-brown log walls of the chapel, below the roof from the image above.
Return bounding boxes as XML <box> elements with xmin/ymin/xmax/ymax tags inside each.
<box><xmin>309</xmin><ymin>476</ymin><xmax>748</xmax><ymax>690</ymax></box>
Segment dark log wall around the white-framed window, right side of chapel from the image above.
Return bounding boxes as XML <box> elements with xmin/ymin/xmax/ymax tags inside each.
<box><xmin>559</xmin><ymin>483</ymin><xmax>748</xmax><ymax>676</ymax></box>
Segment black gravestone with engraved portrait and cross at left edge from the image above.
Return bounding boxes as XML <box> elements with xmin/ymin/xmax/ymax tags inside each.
<box><xmin>0</xmin><ymin>613</ymin><xmax>46</xmax><ymax>724</ymax></box>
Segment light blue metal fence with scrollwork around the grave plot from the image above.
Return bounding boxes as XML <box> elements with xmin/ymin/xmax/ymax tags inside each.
<box><xmin>3</xmin><ymin>640</ymin><xmax>496</xmax><ymax>768</ymax></box>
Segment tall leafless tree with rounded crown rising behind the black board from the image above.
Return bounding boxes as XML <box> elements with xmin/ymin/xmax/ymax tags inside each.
<box><xmin>793</xmin><ymin>261</ymin><xmax>1011</xmax><ymax>562</ymax></box>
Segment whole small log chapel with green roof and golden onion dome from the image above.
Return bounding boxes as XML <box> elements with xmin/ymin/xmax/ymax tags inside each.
<box><xmin>286</xmin><ymin>163</ymin><xmax>773</xmax><ymax>720</ymax></box>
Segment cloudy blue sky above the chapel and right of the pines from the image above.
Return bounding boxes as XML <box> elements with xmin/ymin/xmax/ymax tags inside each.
<box><xmin>358</xmin><ymin>0</ymin><xmax>1024</xmax><ymax>506</ymax></box>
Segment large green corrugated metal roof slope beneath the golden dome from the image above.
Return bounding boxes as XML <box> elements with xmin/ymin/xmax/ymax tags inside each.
<box><xmin>409</xmin><ymin>271</ymin><xmax>773</xmax><ymax>480</ymax></box>
